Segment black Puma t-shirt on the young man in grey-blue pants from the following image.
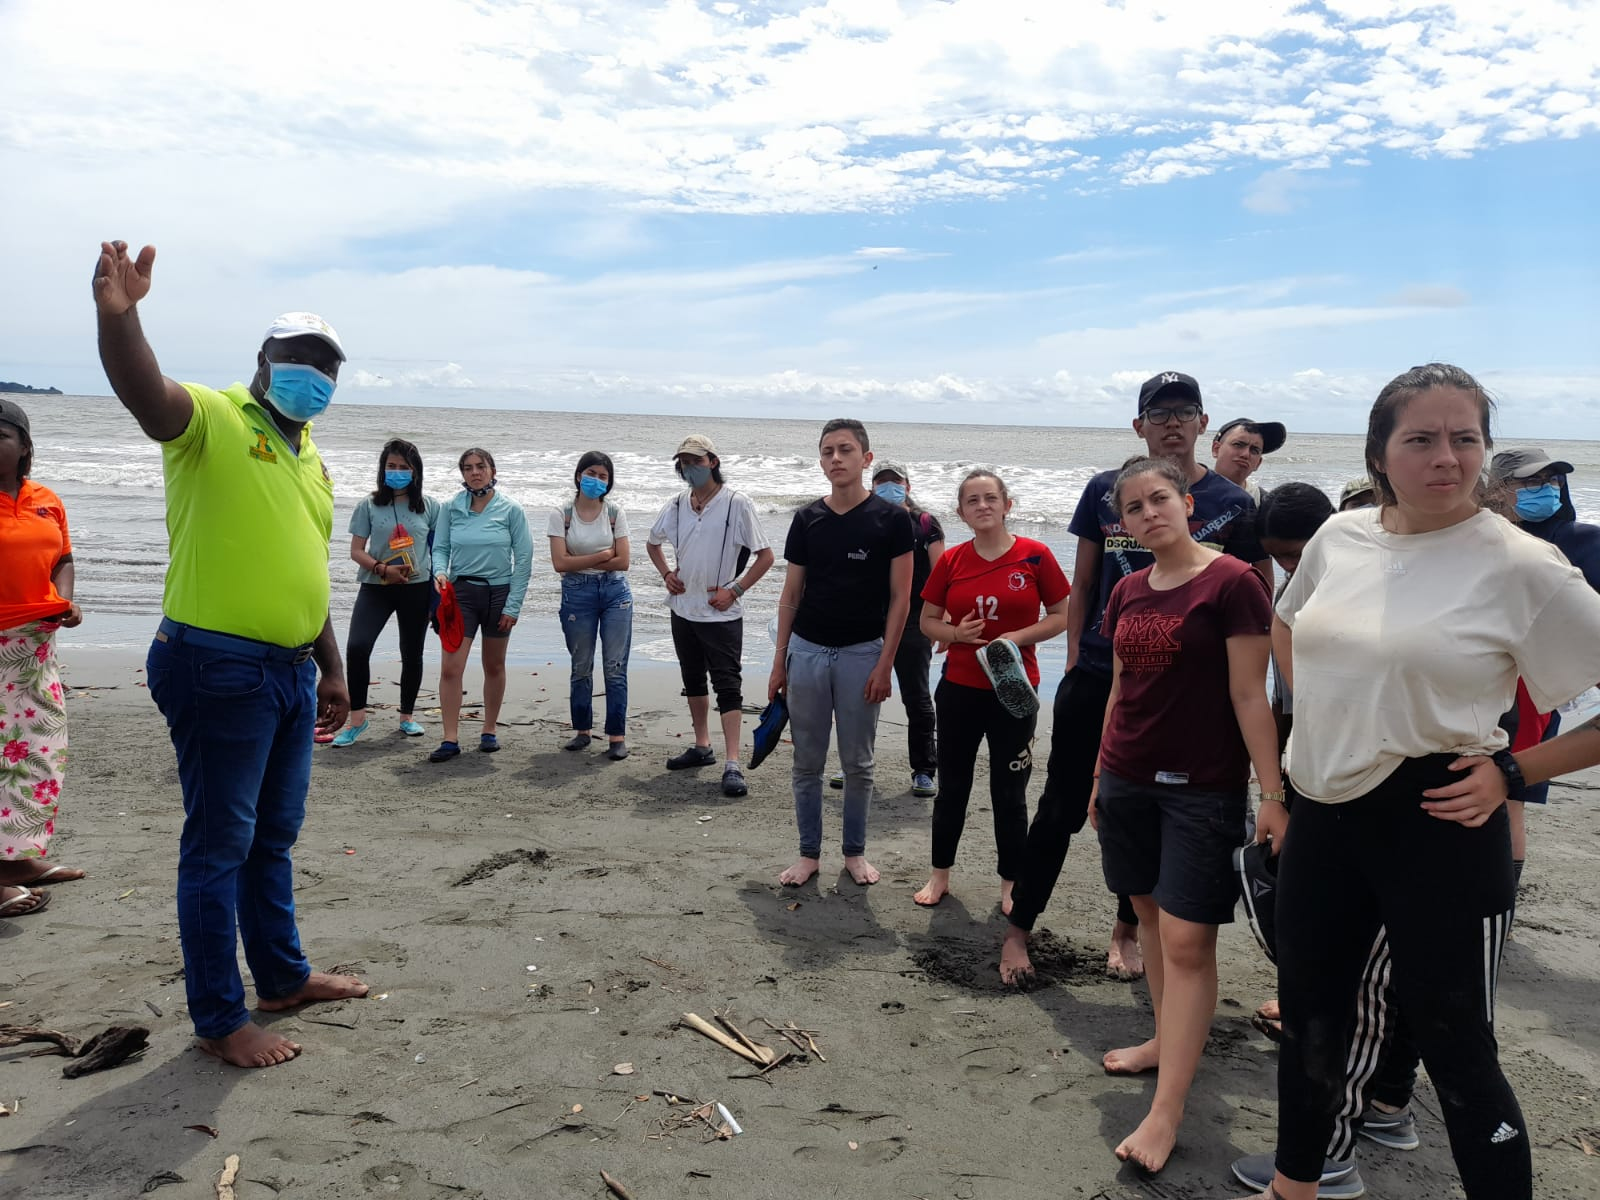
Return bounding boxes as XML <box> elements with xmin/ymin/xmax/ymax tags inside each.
<box><xmin>784</xmin><ymin>494</ymin><xmax>914</xmax><ymax>646</ymax></box>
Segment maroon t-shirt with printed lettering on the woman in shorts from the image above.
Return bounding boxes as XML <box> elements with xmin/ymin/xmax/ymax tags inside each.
<box><xmin>1101</xmin><ymin>555</ymin><xmax>1272</xmax><ymax>790</ymax></box>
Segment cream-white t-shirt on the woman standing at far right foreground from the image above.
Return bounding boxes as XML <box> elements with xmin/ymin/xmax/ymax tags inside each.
<box><xmin>1277</xmin><ymin>509</ymin><xmax>1600</xmax><ymax>803</ymax></box>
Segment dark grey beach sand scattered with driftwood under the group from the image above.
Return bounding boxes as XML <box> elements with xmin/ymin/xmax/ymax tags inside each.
<box><xmin>0</xmin><ymin>654</ymin><xmax>1600</xmax><ymax>1200</ymax></box>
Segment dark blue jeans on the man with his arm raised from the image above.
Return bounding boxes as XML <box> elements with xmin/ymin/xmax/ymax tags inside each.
<box><xmin>146</xmin><ymin>619</ymin><xmax>317</xmax><ymax>1038</ymax></box>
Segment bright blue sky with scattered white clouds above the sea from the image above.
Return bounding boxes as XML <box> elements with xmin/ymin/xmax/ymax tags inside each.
<box><xmin>0</xmin><ymin>0</ymin><xmax>1600</xmax><ymax>438</ymax></box>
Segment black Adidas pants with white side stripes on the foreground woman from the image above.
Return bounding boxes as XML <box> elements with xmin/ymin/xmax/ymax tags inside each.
<box><xmin>1277</xmin><ymin>754</ymin><xmax>1533</xmax><ymax>1200</ymax></box>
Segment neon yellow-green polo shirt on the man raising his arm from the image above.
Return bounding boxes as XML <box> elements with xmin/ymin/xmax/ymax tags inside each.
<box><xmin>162</xmin><ymin>384</ymin><xmax>333</xmax><ymax>646</ymax></box>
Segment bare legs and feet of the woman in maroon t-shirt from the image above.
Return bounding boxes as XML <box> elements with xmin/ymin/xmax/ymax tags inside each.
<box><xmin>1106</xmin><ymin>896</ymin><xmax>1216</xmax><ymax>1177</ymax></box>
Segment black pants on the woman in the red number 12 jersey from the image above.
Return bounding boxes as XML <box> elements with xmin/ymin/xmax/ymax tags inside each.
<box><xmin>933</xmin><ymin>678</ymin><xmax>1038</xmax><ymax>880</ymax></box>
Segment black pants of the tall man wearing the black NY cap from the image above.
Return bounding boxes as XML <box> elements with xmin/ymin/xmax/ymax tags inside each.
<box><xmin>1011</xmin><ymin>667</ymin><xmax>1120</xmax><ymax>930</ymax></box>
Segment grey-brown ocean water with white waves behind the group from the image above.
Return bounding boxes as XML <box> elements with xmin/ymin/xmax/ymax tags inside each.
<box><xmin>18</xmin><ymin>395</ymin><xmax>1600</xmax><ymax>678</ymax></box>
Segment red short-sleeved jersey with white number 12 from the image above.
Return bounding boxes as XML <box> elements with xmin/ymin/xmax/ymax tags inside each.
<box><xmin>922</xmin><ymin>538</ymin><xmax>1072</xmax><ymax>688</ymax></box>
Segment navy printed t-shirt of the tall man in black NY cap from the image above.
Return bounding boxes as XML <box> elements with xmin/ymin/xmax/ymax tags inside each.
<box><xmin>1067</xmin><ymin>470</ymin><xmax>1267</xmax><ymax>678</ymax></box>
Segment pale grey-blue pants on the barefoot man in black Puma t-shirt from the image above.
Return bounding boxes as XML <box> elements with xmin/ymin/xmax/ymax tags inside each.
<box><xmin>784</xmin><ymin>637</ymin><xmax>883</xmax><ymax>858</ymax></box>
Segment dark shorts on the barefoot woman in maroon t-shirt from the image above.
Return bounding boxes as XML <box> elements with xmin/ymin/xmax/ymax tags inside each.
<box><xmin>1096</xmin><ymin>771</ymin><xmax>1250</xmax><ymax>925</ymax></box>
